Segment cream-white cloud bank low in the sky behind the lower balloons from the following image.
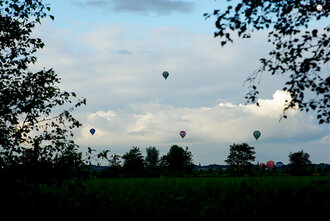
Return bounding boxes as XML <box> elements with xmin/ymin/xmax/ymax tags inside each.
<box><xmin>78</xmin><ymin>91</ymin><xmax>321</xmax><ymax>146</ymax></box>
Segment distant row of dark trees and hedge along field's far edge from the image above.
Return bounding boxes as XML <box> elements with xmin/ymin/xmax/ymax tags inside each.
<box><xmin>89</xmin><ymin>143</ymin><xmax>330</xmax><ymax>178</ymax></box>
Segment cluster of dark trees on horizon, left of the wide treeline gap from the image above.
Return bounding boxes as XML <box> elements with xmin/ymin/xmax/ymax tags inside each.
<box><xmin>89</xmin><ymin>145</ymin><xmax>195</xmax><ymax>178</ymax></box>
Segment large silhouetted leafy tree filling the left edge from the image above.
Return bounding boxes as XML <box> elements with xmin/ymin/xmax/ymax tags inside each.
<box><xmin>0</xmin><ymin>0</ymin><xmax>86</xmax><ymax>179</ymax></box>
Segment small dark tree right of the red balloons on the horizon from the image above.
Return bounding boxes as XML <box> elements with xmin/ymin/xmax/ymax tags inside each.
<box><xmin>289</xmin><ymin>150</ymin><xmax>312</xmax><ymax>176</ymax></box>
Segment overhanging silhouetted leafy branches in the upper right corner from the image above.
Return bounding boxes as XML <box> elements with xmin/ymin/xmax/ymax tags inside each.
<box><xmin>204</xmin><ymin>0</ymin><xmax>330</xmax><ymax>124</ymax></box>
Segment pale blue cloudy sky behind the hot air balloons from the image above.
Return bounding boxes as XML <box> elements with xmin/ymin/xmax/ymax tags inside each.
<box><xmin>33</xmin><ymin>0</ymin><xmax>330</xmax><ymax>165</ymax></box>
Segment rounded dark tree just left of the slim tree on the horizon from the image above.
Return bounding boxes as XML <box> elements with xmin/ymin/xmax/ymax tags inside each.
<box><xmin>122</xmin><ymin>147</ymin><xmax>144</xmax><ymax>176</ymax></box>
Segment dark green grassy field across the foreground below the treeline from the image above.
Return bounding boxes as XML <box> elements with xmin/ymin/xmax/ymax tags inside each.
<box><xmin>4</xmin><ymin>176</ymin><xmax>330</xmax><ymax>220</ymax></box>
